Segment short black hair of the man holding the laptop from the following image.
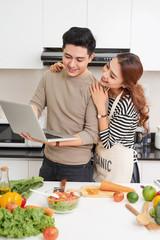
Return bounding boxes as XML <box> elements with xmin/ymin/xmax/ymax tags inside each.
<box><xmin>62</xmin><ymin>27</ymin><xmax>96</xmax><ymax>56</ymax></box>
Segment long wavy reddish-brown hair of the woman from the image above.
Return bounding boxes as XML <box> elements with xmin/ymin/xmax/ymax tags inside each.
<box><xmin>117</xmin><ymin>53</ymin><xmax>149</xmax><ymax>133</ymax></box>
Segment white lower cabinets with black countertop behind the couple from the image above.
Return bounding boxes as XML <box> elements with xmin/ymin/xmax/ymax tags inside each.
<box><xmin>0</xmin><ymin>144</ymin><xmax>160</xmax><ymax>183</ymax></box>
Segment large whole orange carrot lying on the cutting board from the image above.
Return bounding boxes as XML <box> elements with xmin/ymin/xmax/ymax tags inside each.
<box><xmin>100</xmin><ymin>180</ymin><xmax>135</xmax><ymax>192</ymax></box>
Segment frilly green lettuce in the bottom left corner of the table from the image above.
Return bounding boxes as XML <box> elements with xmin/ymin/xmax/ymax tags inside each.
<box><xmin>0</xmin><ymin>207</ymin><xmax>54</xmax><ymax>238</ymax></box>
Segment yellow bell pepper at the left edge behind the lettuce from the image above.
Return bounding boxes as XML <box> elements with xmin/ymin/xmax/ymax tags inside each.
<box><xmin>0</xmin><ymin>192</ymin><xmax>22</xmax><ymax>208</ymax></box>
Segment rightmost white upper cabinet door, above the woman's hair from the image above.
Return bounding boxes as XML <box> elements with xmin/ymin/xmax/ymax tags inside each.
<box><xmin>131</xmin><ymin>0</ymin><xmax>160</xmax><ymax>71</ymax></box>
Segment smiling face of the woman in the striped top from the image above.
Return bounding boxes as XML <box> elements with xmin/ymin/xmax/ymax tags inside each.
<box><xmin>100</xmin><ymin>58</ymin><xmax>125</xmax><ymax>89</ymax></box>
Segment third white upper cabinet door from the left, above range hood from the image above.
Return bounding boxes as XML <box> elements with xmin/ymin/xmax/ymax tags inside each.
<box><xmin>88</xmin><ymin>0</ymin><xmax>132</xmax><ymax>48</ymax></box>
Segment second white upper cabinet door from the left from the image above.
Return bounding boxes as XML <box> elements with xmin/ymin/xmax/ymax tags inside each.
<box><xmin>43</xmin><ymin>0</ymin><xmax>87</xmax><ymax>47</ymax></box>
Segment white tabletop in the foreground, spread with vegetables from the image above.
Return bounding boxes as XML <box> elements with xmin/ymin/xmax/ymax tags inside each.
<box><xmin>0</xmin><ymin>182</ymin><xmax>160</xmax><ymax>240</ymax></box>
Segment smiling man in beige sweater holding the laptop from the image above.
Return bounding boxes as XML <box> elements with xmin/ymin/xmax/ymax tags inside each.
<box><xmin>23</xmin><ymin>27</ymin><xmax>98</xmax><ymax>182</ymax></box>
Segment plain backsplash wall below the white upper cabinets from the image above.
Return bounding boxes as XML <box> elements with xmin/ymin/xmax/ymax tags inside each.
<box><xmin>0</xmin><ymin>67</ymin><xmax>160</xmax><ymax>132</ymax></box>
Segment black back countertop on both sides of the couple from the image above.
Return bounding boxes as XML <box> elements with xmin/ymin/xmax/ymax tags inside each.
<box><xmin>0</xmin><ymin>144</ymin><xmax>160</xmax><ymax>161</ymax></box>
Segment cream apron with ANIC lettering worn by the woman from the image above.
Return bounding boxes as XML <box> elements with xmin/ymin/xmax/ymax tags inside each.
<box><xmin>93</xmin><ymin>91</ymin><xmax>134</xmax><ymax>183</ymax></box>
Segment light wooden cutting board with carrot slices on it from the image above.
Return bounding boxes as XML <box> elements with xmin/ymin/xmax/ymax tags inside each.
<box><xmin>67</xmin><ymin>186</ymin><xmax>114</xmax><ymax>198</ymax></box>
